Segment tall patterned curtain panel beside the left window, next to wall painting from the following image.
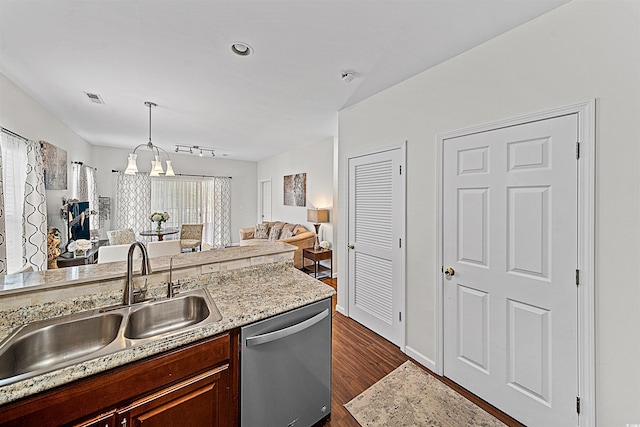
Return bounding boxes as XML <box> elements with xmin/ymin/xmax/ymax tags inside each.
<box><xmin>22</xmin><ymin>141</ymin><xmax>47</xmax><ymax>270</ymax></box>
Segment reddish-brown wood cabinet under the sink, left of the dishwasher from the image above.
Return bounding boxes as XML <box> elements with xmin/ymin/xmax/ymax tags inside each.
<box><xmin>0</xmin><ymin>330</ymin><xmax>238</xmax><ymax>427</ymax></box>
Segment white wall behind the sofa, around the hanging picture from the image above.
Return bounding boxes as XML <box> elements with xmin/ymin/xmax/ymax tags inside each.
<box><xmin>256</xmin><ymin>138</ymin><xmax>335</xmax><ymax>249</ymax></box>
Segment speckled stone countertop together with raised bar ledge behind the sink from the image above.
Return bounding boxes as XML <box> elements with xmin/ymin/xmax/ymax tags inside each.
<box><xmin>0</xmin><ymin>243</ymin><xmax>335</xmax><ymax>426</ymax></box>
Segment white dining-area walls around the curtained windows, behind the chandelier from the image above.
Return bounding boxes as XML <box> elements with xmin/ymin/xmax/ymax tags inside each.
<box><xmin>0</xmin><ymin>74</ymin><xmax>257</xmax><ymax>247</ymax></box>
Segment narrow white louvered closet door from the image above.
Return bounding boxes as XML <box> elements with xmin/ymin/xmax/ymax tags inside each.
<box><xmin>349</xmin><ymin>149</ymin><xmax>403</xmax><ymax>345</ymax></box>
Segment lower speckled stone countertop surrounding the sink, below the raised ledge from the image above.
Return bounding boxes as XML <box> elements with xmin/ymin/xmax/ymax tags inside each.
<box><xmin>0</xmin><ymin>248</ymin><xmax>335</xmax><ymax>405</ymax></box>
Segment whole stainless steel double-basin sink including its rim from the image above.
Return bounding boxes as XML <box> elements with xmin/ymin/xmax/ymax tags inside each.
<box><xmin>0</xmin><ymin>289</ymin><xmax>222</xmax><ymax>386</ymax></box>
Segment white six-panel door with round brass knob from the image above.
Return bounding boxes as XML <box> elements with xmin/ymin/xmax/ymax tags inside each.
<box><xmin>443</xmin><ymin>114</ymin><xmax>578</xmax><ymax>427</ymax></box>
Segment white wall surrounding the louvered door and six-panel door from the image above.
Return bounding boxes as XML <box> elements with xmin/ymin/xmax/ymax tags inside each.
<box><xmin>337</xmin><ymin>0</ymin><xmax>640</xmax><ymax>426</ymax></box>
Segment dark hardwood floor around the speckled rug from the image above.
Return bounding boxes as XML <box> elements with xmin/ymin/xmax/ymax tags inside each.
<box><xmin>320</xmin><ymin>279</ymin><xmax>524</xmax><ymax>427</ymax></box>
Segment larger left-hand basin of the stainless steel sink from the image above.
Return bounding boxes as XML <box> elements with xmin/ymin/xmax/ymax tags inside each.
<box><xmin>0</xmin><ymin>313</ymin><xmax>124</xmax><ymax>379</ymax></box>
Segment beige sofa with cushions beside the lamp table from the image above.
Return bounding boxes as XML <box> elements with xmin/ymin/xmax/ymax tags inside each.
<box><xmin>240</xmin><ymin>221</ymin><xmax>316</xmax><ymax>268</ymax></box>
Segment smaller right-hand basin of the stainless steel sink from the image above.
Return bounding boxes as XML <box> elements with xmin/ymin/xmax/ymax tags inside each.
<box><xmin>124</xmin><ymin>295</ymin><xmax>222</xmax><ymax>340</ymax></box>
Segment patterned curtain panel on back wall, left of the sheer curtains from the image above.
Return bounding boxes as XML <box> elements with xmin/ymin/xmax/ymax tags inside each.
<box><xmin>116</xmin><ymin>172</ymin><xmax>151</xmax><ymax>241</ymax></box>
